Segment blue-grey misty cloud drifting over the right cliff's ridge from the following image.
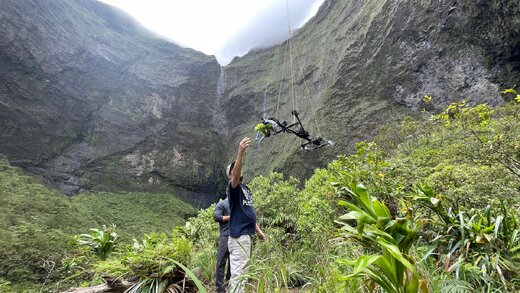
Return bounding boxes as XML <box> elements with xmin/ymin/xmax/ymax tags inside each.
<box><xmin>215</xmin><ymin>0</ymin><xmax>324</xmax><ymax>65</ymax></box>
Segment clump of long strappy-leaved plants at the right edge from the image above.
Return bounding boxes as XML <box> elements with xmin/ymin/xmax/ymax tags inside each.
<box><xmin>414</xmin><ymin>185</ymin><xmax>520</xmax><ymax>286</ymax></box>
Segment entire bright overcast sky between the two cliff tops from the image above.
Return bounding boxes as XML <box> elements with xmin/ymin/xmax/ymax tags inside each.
<box><xmin>101</xmin><ymin>0</ymin><xmax>324</xmax><ymax>65</ymax></box>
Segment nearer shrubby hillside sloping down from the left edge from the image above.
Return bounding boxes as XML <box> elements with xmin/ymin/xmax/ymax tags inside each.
<box><xmin>0</xmin><ymin>160</ymin><xmax>91</xmax><ymax>291</ymax></box>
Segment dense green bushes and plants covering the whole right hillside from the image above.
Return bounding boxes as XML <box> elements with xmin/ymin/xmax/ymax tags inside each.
<box><xmin>175</xmin><ymin>97</ymin><xmax>520</xmax><ymax>292</ymax></box>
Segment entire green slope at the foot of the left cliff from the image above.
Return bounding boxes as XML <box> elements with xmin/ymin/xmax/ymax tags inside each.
<box><xmin>0</xmin><ymin>159</ymin><xmax>196</xmax><ymax>292</ymax></box>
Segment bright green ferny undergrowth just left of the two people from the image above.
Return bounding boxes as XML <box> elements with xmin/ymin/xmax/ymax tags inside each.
<box><xmin>62</xmin><ymin>230</ymin><xmax>204</xmax><ymax>292</ymax></box>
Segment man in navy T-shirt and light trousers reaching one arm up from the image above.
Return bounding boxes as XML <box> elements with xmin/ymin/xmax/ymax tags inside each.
<box><xmin>226</xmin><ymin>137</ymin><xmax>265</xmax><ymax>293</ymax></box>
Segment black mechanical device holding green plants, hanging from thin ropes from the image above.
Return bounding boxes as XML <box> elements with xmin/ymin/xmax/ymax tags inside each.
<box><xmin>255</xmin><ymin>110</ymin><xmax>334</xmax><ymax>150</ymax></box>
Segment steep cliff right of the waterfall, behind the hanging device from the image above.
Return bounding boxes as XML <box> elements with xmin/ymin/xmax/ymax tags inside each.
<box><xmin>220</xmin><ymin>0</ymin><xmax>520</xmax><ymax>176</ymax></box>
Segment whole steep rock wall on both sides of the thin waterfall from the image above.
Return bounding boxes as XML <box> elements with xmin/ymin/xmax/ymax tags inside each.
<box><xmin>0</xmin><ymin>0</ymin><xmax>520</xmax><ymax>205</ymax></box>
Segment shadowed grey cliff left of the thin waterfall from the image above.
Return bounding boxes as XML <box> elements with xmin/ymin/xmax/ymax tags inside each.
<box><xmin>0</xmin><ymin>0</ymin><xmax>220</xmax><ymax>204</ymax></box>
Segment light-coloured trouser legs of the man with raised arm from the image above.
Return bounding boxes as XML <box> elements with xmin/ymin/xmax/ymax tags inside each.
<box><xmin>228</xmin><ymin>235</ymin><xmax>253</xmax><ymax>293</ymax></box>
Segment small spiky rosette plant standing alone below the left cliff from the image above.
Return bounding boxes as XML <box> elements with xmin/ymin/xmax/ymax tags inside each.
<box><xmin>77</xmin><ymin>225</ymin><xmax>119</xmax><ymax>260</ymax></box>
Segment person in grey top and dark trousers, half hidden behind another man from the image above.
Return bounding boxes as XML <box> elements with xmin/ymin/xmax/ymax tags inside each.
<box><xmin>213</xmin><ymin>198</ymin><xmax>231</xmax><ymax>293</ymax></box>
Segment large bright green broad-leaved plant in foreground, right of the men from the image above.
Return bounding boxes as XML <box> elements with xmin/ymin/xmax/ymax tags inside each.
<box><xmin>335</xmin><ymin>171</ymin><xmax>427</xmax><ymax>293</ymax></box>
